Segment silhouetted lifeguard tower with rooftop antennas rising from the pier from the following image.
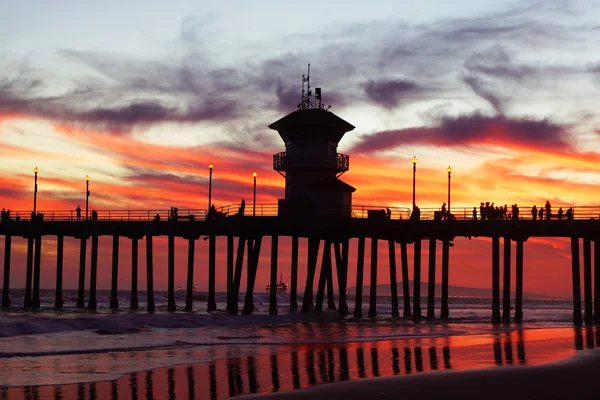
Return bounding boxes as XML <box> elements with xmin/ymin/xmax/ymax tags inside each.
<box><xmin>269</xmin><ymin>64</ymin><xmax>356</xmax><ymax>217</ymax></box>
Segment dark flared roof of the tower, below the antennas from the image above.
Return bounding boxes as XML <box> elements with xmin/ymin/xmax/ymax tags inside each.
<box><xmin>269</xmin><ymin>108</ymin><xmax>354</xmax><ymax>143</ymax></box>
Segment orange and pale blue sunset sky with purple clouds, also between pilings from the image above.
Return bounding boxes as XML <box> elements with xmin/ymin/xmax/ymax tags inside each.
<box><xmin>0</xmin><ymin>0</ymin><xmax>600</xmax><ymax>295</ymax></box>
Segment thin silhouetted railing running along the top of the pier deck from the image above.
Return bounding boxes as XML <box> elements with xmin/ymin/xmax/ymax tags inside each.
<box><xmin>4</xmin><ymin>204</ymin><xmax>600</xmax><ymax>221</ymax></box>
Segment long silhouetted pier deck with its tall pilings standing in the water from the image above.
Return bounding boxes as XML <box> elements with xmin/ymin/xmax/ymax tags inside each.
<box><xmin>0</xmin><ymin>208</ymin><xmax>600</xmax><ymax>325</ymax></box>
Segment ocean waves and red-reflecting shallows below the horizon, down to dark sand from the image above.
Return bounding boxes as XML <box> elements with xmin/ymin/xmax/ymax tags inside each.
<box><xmin>0</xmin><ymin>290</ymin><xmax>600</xmax><ymax>399</ymax></box>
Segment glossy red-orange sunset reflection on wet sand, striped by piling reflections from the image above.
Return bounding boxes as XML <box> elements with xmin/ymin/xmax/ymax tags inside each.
<box><xmin>0</xmin><ymin>328</ymin><xmax>600</xmax><ymax>400</ymax></box>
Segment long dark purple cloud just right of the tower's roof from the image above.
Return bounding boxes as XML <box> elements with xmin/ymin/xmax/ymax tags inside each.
<box><xmin>352</xmin><ymin>113</ymin><xmax>571</xmax><ymax>153</ymax></box>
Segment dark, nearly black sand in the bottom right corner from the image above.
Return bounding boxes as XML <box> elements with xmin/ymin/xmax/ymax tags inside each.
<box><xmin>250</xmin><ymin>350</ymin><xmax>600</xmax><ymax>400</ymax></box>
